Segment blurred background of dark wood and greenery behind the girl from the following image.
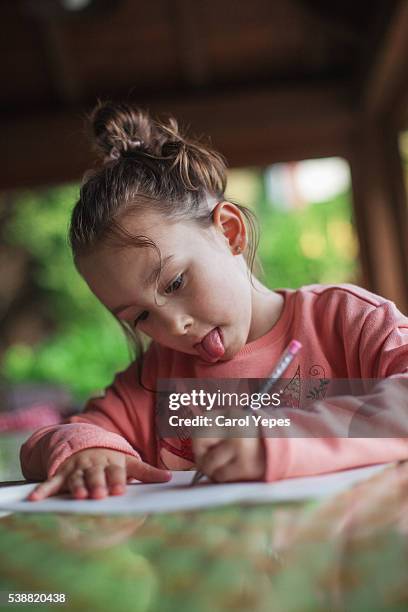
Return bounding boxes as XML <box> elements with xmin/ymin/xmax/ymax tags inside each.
<box><xmin>0</xmin><ymin>0</ymin><xmax>408</xmax><ymax>473</ymax></box>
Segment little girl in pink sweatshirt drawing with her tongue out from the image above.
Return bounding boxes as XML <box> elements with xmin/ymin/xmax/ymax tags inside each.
<box><xmin>20</xmin><ymin>103</ymin><xmax>408</xmax><ymax>500</ymax></box>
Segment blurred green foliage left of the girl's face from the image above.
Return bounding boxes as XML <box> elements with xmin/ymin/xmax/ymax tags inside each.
<box><xmin>1</xmin><ymin>185</ymin><xmax>129</xmax><ymax>401</ymax></box>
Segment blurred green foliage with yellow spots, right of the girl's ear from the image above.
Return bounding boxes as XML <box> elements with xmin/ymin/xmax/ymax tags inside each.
<box><xmin>258</xmin><ymin>193</ymin><xmax>358</xmax><ymax>288</ymax></box>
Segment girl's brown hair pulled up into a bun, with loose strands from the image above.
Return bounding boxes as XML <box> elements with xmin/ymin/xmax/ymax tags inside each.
<box><xmin>69</xmin><ymin>102</ymin><xmax>259</xmax><ymax>370</ymax></box>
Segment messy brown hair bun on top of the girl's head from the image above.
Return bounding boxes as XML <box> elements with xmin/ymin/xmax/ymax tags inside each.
<box><xmin>90</xmin><ymin>102</ymin><xmax>163</xmax><ymax>161</ymax></box>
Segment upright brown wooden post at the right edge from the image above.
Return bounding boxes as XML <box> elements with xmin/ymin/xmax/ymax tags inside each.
<box><xmin>349</xmin><ymin>120</ymin><xmax>408</xmax><ymax>313</ymax></box>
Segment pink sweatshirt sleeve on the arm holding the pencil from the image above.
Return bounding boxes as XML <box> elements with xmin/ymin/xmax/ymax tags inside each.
<box><xmin>262</xmin><ymin>302</ymin><xmax>408</xmax><ymax>482</ymax></box>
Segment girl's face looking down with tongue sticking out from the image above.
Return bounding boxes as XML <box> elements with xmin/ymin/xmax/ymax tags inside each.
<box><xmin>79</xmin><ymin>205</ymin><xmax>272</xmax><ymax>363</ymax></box>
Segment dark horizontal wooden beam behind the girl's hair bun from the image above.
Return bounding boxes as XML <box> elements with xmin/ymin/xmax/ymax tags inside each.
<box><xmin>0</xmin><ymin>87</ymin><xmax>355</xmax><ymax>190</ymax></box>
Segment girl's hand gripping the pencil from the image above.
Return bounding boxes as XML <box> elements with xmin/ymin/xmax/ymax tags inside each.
<box><xmin>192</xmin><ymin>437</ymin><xmax>266</xmax><ymax>482</ymax></box>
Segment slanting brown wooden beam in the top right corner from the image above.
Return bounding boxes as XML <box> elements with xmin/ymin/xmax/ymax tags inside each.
<box><xmin>362</xmin><ymin>0</ymin><xmax>408</xmax><ymax>127</ymax></box>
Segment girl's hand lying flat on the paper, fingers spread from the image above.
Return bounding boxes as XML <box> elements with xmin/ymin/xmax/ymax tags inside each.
<box><xmin>27</xmin><ymin>448</ymin><xmax>171</xmax><ymax>501</ymax></box>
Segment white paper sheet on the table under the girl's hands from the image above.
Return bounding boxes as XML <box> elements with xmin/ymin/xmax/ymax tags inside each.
<box><xmin>0</xmin><ymin>464</ymin><xmax>390</xmax><ymax>515</ymax></box>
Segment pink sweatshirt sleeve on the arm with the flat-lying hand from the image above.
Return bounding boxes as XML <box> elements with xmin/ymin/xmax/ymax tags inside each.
<box><xmin>20</xmin><ymin>345</ymin><xmax>157</xmax><ymax>480</ymax></box>
